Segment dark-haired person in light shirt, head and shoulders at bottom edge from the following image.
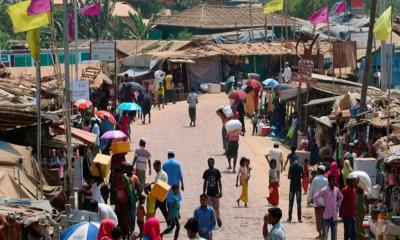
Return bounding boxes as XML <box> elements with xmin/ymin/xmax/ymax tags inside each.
<box><xmin>263</xmin><ymin>207</ymin><xmax>286</xmax><ymax>240</ymax></box>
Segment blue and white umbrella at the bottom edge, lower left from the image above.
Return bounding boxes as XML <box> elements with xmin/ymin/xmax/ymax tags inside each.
<box><xmin>60</xmin><ymin>222</ymin><xmax>100</xmax><ymax>240</ymax></box>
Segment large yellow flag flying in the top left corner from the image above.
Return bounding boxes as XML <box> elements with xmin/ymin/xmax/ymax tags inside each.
<box><xmin>7</xmin><ymin>1</ymin><xmax>50</xmax><ymax>33</ymax></box>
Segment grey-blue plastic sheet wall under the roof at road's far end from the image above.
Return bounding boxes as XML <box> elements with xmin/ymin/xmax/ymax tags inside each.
<box><xmin>188</xmin><ymin>57</ymin><xmax>222</xmax><ymax>89</ymax></box>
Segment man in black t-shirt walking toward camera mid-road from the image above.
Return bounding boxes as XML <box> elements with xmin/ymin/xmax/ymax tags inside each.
<box><xmin>203</xmin><ymin>158</ymin><xmax>222</xmax><ymax>227</ymax></box>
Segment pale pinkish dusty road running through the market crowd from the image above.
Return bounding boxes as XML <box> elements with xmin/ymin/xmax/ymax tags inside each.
<box><xmin>128</xmin><ymin>94</ymin><xmax>343</xmax><ymax>240</ymax></box>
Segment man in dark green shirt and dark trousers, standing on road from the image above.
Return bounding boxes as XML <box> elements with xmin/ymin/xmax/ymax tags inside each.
<box><xmin>287</xmin><ymin>158</ymin><xmax>303</xmax><ymax>223</ymax></box>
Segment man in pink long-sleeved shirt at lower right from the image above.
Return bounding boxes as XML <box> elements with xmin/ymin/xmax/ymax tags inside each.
<box><xmin>313</xmin><ymin>174</ymin><xmax>343</xmax><ymax>240</ymax></box>
